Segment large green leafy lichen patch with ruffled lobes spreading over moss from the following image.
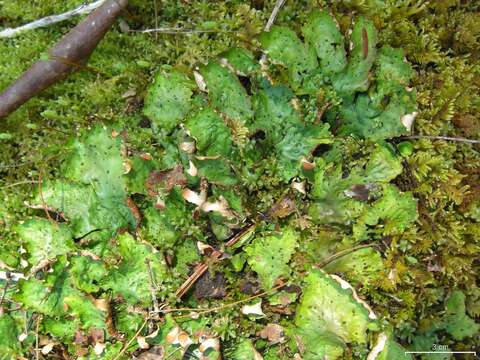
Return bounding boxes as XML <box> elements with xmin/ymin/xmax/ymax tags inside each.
<box><xmin>0</xmin><ymin>11</ymin><xmax>436</xmax><ymax>360</ymax></box>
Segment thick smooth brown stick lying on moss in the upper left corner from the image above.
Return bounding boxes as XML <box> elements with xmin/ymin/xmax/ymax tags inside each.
<box><xmin>0</xmin><ymin>0</ymin><xmax>128</xmax><ymax>118</ymax></box>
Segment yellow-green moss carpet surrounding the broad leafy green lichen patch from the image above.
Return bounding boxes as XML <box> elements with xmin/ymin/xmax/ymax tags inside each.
<box><xmin>0</xmin><ymin>0</ymin><xmax>480</xmax><ymax>356</ymax></box>
